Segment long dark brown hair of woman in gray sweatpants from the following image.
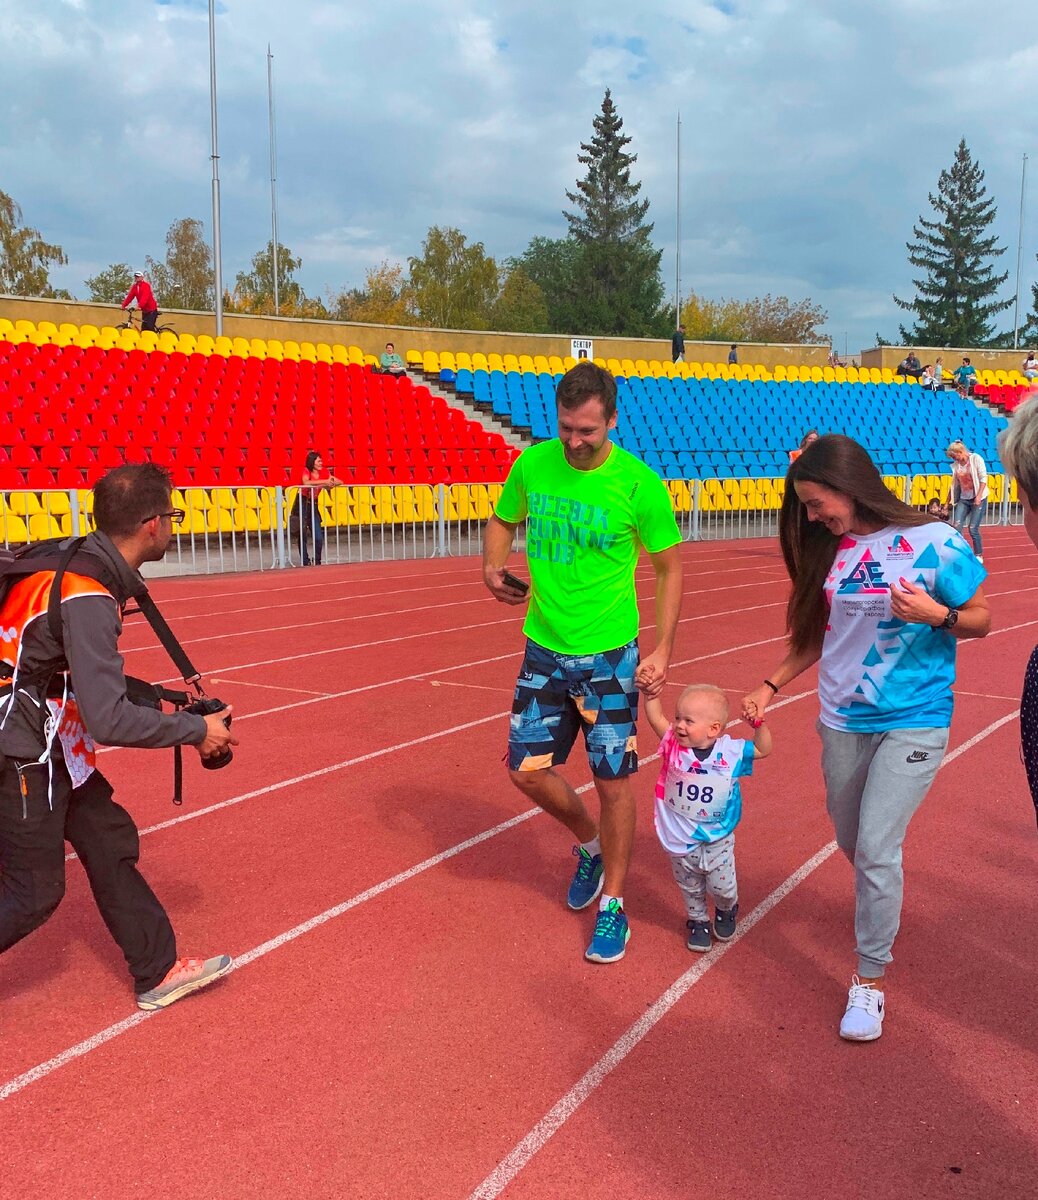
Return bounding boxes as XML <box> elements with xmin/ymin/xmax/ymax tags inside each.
<box><xmin>779</xmin><ymin>433</ymin><xmax>934</xmax><ymax>653</ymax></box>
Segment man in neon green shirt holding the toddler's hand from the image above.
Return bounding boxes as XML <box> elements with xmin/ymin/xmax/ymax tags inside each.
<box><xmin>482</xmin><ymin>361</ymin><xmax>682</xmax><ymax>962</ymax></box>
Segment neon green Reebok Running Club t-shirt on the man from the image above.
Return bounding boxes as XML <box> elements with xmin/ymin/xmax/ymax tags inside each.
<box><xmin>494</xmin><ymin>438</ymin><xmax>682</xmax><ymax>654</ymax></box>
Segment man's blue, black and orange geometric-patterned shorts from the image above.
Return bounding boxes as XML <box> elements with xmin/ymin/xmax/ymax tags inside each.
<box><xmin>508</xmin><ymin>641</ymin><xmax>638</xmax><ymax>779</ymax></box>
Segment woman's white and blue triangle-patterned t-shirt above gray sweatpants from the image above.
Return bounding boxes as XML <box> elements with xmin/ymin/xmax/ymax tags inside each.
<box><xmin>818</xmin><ymin>521</ymin><xmax>988</xmax><ymax>733</ymax></box>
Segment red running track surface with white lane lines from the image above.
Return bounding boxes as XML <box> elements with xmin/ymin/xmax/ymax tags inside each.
<box><xmin>0</xmin><ymin>530</ymin><xmax>1038</xmax><ymax>1200</ymax></box>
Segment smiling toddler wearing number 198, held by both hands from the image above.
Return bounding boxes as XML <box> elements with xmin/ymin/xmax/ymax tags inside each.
<box><xmin>646</xmin><ymin>684</ymin><xmax>772</xmax><ymax>952</ymax></box>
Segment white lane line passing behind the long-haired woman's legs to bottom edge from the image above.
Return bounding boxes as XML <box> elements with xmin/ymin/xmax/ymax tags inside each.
<box><xmin>469</xmin><ymin>710</ymin><xmax>1019</xmax><ymax>1200</ymax></box>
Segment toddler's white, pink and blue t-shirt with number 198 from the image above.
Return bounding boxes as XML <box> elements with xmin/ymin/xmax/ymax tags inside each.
<box><xmin>655</xmin><ymin>730</ymin><xmax>754</xmax><ymax>854</ymax></box>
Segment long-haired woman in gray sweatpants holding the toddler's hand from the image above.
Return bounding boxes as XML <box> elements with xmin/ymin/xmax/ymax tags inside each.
<box><xmin>743</xmin><ymin>433</ymin><xmax>990</xmax><ymax>1042</ymax></box>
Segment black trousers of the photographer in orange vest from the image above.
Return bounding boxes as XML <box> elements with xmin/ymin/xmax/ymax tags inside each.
<box><xmin>0</xmin><ymin>756</ymin><xmax>176</xmax><ymax>992</ymax></box>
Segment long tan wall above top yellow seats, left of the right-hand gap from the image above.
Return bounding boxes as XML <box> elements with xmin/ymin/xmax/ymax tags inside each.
<box><xmin>0</xmin><ymin>295</ymin><xmax>829</xmax><ymax>367</ymax></box>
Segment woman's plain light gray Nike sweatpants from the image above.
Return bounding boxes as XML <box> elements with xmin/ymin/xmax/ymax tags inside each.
<box><xmin>818</xmin><ymin>721</ymin><xmax>948</xmax><ymax>979</ymax></box>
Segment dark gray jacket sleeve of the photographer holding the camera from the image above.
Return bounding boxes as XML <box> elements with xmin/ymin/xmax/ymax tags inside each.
<box><xmin>61</xmin><ymin>595</ymin><xmax>205</xmax><ymax>749</ymax></box>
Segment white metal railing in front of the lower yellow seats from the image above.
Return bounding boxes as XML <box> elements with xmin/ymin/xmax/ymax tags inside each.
<box><xmin>0</xmin><ymin>475</ymin><xmax>1024</xmax><ymax>575</ymax></box>
